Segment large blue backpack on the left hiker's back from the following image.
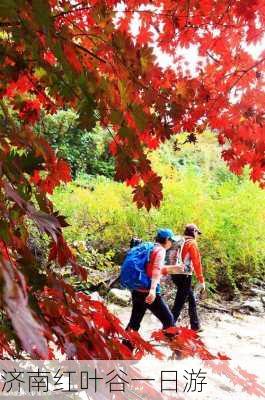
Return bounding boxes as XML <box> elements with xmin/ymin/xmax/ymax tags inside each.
<box><xmin>120</xmin><ymin>242</ymin><xmax>155</xmax><ymax>290</ymax></box>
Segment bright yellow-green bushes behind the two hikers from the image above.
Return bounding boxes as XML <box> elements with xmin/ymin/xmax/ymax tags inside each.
<box><xmin>53</xmin><ymin>134</ymin><xmax>265</xmax><ymax>289</ymax></box>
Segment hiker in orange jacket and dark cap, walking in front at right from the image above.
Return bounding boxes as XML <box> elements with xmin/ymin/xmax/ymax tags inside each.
<box><xmin>163</xmin><ymin>224</ymin><xmax>205</xmax><ymax>331</ymax></box>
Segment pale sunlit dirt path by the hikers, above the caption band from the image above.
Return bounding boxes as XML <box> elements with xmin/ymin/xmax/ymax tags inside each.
<box><xmin>109</xmin><ymin>304</ymin><xmax>265</xmax><ymax>359</ymax></box>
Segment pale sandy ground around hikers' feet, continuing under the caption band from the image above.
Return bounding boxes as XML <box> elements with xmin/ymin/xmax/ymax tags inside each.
<box><xmin>108</xmin><ymin>303</ymin><xmax>265</xmax><ymax>400</ymax></box>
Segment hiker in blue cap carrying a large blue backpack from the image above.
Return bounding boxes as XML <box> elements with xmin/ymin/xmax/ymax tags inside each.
<box><xmin>121</xmin><ymin>229</ymin><xmax>175</xmax><ymax>331</ymax></box>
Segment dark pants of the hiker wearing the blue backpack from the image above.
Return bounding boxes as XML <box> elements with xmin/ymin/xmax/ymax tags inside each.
<box><xmin>126</xmin><ymin>290</ymin><xmax>174</xmax><ymax>331</ymax></box>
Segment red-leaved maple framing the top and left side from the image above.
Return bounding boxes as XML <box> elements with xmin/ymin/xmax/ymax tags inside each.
<box><xmin>0</xmin><ymin>0</ymin><xmax>265</xmax><ymax>358</ymax></box>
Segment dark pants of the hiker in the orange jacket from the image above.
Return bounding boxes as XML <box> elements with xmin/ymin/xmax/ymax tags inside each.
<box><xmin>172</xmin><ymin>275</ymin><xmax>200</xmax><ymax>330</ymax></box>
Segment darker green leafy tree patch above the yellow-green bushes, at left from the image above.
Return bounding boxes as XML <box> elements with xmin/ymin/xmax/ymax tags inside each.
<box><xmin>37</xmin><ymin>109</ymin><xmax>114</xmax><ymax>177</ymax></box>
